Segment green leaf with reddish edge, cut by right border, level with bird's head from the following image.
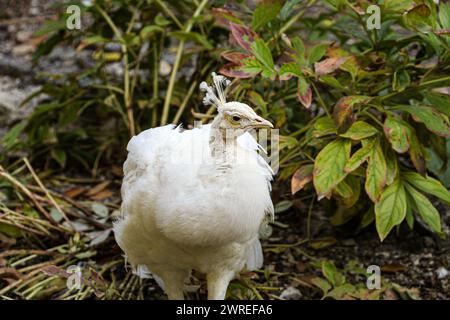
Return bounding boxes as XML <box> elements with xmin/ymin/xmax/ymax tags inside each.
<box><xmin>396</xmin><ymin>106</ymin><xmax>450</xmax><ymax>137</ymax></box>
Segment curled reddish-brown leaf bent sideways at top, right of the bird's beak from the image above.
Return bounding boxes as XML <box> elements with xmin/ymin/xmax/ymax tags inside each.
<box><xmin>333</xmin><ymin>96</ymin><xmax>371</xmax><ymax>133</ymax></box>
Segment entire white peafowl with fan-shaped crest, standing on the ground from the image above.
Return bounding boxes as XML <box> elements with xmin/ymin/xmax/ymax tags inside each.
<box><xmin>114</xmin><ymin>74</ymin><xmax>273</xmax><ymax>299</ymax></box>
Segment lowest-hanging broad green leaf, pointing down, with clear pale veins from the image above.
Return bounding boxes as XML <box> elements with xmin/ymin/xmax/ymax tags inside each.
<box><xmin>375</xmin><ymin>179</ymin><xmax>407</xmax><ymax>241</ymax></box>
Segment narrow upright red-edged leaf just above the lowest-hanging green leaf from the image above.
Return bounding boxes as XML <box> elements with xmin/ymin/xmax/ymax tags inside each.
<box><xmin>365</xmin><ymin>140</ymin><xmax>387</xmax><ymax>203</ymax></box>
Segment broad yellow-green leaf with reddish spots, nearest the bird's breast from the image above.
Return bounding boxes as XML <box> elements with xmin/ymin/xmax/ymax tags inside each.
<box><xmin>313</xmin><ymin>139</ymin><xmax>351</xmax><ymax>200</ymax></box>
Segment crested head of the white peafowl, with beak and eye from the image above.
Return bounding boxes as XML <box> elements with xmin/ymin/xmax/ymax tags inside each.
<box><xmin>200</xmin><ymin>72</ymin><xmax>273</xmax><ymax>132</ymax></box>
